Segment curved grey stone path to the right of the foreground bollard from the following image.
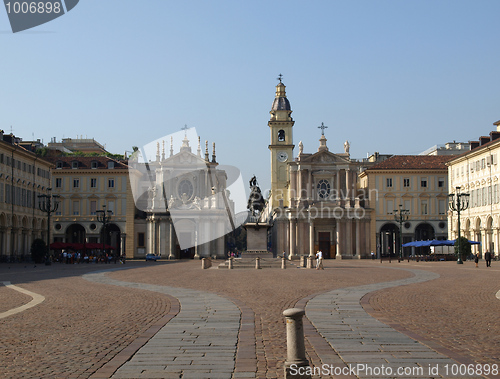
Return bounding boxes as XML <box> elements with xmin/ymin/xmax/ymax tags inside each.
<box><xmin>306</xmin><ymin>269</ymin><xmax>482</xmax><ymax>378</ymax></box>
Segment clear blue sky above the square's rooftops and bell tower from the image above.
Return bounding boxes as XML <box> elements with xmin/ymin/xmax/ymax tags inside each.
<box><xmin>0</xmin><ymin>0</ymin><xmax>500</xmax><ymax>193</ymax></box>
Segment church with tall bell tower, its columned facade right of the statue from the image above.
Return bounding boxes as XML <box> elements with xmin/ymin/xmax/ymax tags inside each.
<box><xmin>263</xmin><ymin>79</ymin><xmax>371</xmax><ymax>259</ymax></box>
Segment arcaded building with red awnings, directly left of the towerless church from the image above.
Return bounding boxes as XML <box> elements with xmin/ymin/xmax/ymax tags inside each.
<box><xmin>47</xmin><ymin>156</ymin><xmax>130</xmax><ymax>257</ymax></box>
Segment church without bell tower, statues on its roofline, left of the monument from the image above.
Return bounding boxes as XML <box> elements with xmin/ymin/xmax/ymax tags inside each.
<box><xmin>130</xmin><ymin>134</ymin><xmax>237</xmax><ymax>259</ymax></box>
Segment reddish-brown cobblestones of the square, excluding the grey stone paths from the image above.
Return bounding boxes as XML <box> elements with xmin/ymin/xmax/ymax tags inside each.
<box><xmin>0</xmin><ymin>261</ymin><xmax>500</xmax><ymax>378</ymax></box>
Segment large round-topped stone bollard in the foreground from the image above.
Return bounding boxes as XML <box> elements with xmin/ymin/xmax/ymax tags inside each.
<box><xmin>283</xmin><ymin>308</ymin><xmax>311</xmax><ymax>379</ymax></box>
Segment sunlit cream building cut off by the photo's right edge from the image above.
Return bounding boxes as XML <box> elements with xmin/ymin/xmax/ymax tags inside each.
<box><xmin>448</xmin><ymin>121</ymin><xmax>500</xmax><ymax>255</ymax></box>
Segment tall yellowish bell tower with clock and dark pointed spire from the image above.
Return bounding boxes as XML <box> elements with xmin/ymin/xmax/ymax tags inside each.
<box><xmin>268</xmin><ymin>74</ymin><xmax>295</xmax><ymax>208</ymax></box>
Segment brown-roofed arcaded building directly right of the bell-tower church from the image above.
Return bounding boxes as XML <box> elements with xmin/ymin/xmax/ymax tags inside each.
<box><xmin>359</xmin><ymin>155</ymin><xmax>450</xmax><ymax>256</ymax></box>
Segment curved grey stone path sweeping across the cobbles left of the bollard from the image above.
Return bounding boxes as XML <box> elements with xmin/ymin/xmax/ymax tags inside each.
<box><xmin>83</xmin><ymin>272</ymin><xmax>241</xmax><ymax>379</ymax></box>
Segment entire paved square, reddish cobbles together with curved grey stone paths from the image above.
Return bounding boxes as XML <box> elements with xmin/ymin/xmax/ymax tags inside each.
<box><xmin>0</xmin><ymin>260</ymin><xmax>500</xmax><ymax>379</ymax></box>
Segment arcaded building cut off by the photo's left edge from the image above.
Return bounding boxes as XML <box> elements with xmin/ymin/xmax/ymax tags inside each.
<box><xmin>0</xmin><ymin>131</ymin><xmax>52</xmax><ymax>261</ymax></box>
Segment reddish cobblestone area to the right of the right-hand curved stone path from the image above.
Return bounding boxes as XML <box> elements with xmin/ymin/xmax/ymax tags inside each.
<box><xmin>365</xmin><ymin>261</ymin><xmax>500</xmax><ymax>372</ymax></box>
